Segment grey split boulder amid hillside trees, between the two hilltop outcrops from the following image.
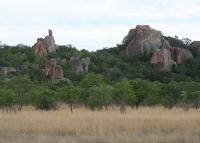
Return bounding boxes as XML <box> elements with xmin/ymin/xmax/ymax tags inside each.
<box><xmin>70</xmin><ymin>52</ymin><xmax>90</xmax><ymax>74</ymax></box>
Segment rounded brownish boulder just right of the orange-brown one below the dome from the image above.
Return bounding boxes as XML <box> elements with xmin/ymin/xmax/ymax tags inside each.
<box><xmin>172</xmin><ymin>47</ymin><xmax>194</xmax><ymax>64</ymax></box>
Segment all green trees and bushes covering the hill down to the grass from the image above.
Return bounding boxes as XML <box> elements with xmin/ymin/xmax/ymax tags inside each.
<box><xmin>0</xmin><ymin>35</ymin><xmax>200</xmax><ymax>113</ymax></box>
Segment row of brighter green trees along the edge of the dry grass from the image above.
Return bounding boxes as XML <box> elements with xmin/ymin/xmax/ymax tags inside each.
<box><xmin>0</xmin><ymin>73</ymin><xmax>200</xmax><ymax>113</ymax></box>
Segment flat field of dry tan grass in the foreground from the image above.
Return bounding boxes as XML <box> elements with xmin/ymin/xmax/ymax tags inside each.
<box><xmin>0</xmin><ymin>107</ymin><xmax>200</xmax><ymax>143</ymax></box>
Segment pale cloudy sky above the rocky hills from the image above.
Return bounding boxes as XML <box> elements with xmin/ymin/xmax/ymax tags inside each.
<box><xmin>0</xmin><ymin>0</ymin><xmax>200</xmax><ymax>51</ymax></box>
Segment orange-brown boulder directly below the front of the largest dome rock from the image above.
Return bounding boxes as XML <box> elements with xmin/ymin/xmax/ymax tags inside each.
<box><xmin>151</xmin><ymin>49</ymin><xmax>176</xmax><ymax>71</ymax></box>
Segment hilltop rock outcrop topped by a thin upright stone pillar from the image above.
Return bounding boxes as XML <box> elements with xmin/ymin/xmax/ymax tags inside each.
<box><xmin>32</xmin><ymin>30</ymin><xmax>56</xmax><ymax>56</ymax></box>
